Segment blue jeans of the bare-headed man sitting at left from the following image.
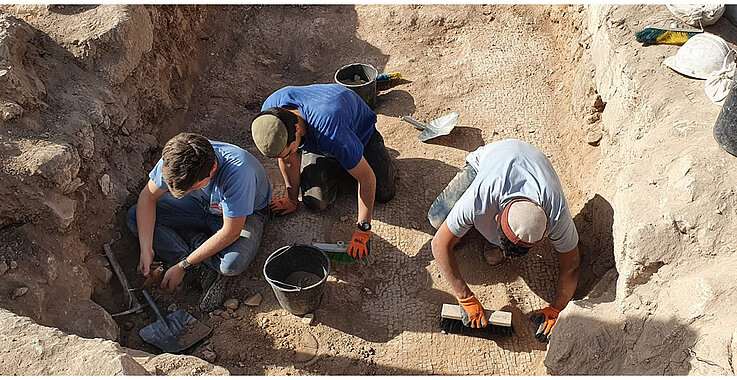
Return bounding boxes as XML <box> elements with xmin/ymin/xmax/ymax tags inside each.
<box><xmin>127</xmin><ymin>192</ymin><xmax>268</xmax><ymax>276</ymax></box>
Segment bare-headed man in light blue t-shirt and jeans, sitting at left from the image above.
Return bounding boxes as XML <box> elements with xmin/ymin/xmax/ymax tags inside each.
<box><xmin>127</xmin><ymin>133</ymin><xmax>271</xmax><ymax>311</ymax></box>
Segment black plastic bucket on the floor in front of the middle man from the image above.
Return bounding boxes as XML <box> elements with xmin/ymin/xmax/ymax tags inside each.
<box><xmin>264</xmin><ymin>244</ymin><xmax>330</xmax><ymax>315</ymax></box>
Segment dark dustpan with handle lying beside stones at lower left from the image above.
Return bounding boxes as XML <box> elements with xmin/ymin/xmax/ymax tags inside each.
<box><xmin>138</xmin><ymin>290</ymin><xmax>212</xmax><ymax>354</ymax></box>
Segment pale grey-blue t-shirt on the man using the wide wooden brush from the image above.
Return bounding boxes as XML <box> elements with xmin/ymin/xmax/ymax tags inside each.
<box><xmin>446</xmin><ymin>139</ymin><xmax>578</xmax><ymax>252</ymax></box>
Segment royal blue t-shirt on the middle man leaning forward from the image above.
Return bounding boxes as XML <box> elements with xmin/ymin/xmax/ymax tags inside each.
<box><xmin>261</xmin><ymin>84</ymin><xmax>376</xmax><ymax>170</ymax></box>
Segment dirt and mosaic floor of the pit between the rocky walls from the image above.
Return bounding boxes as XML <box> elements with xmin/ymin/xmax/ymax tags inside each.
<box><xmin>94</xmin><ymin>5</ymin><xmax>613</xmax><ymax>375</ymax></box>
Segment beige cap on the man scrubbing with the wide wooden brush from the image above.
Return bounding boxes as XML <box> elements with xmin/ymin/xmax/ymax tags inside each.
<box><xmin>501</xmin><ymin>199</ymin><xmax>548</xmax><ymax>247</ymax></box>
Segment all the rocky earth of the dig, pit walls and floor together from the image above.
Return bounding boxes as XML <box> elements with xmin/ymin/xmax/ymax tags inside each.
<box><xmin>0</xmin><ymin>5</ymin><xmax>737</xmax><ymax>375</ymax></box>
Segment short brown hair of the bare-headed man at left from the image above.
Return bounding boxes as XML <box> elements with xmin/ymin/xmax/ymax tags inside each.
<box><xmin>161</xmin><ymin>132</ymin><xmax>217</xmax><ymax>198</ymax></box>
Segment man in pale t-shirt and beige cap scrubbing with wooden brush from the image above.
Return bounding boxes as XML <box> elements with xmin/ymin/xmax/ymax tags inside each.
<box><xmin>428</xmin><ymin>139</ymin><xmax>579</xmax><ymax>341</ymax></box>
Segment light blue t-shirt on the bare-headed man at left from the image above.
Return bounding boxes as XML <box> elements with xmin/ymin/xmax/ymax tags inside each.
<box><xmin>148</xmin><ymin>140</ymin><xmax>271</xmax><ymax>218</ymax></box>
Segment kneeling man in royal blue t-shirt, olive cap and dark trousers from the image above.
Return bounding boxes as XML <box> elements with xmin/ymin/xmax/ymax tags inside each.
<box><xmin>251</xmin><ymin>84</ymin><xmax>396</xmax><ymax>258</ymax></box>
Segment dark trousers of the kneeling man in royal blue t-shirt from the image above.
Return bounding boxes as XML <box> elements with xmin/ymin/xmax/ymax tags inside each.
<box><xmin>300</xmin><ymin>129</ymin><xmax>397</xmax><ymax>211</ymax></box>
